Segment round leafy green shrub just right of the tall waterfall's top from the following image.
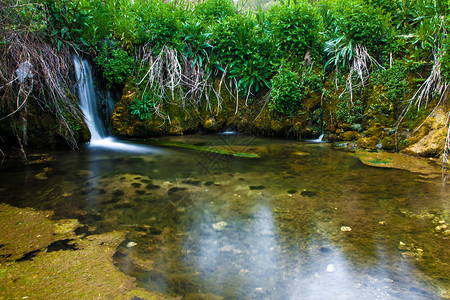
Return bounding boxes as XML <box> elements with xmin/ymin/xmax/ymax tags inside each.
<box><xmin>95</xmin><ymin>41</ymin><xmax>134</xmax><ymax>88</ymax></box>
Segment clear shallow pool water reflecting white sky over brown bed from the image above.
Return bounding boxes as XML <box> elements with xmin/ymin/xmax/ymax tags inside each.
<box><xmin>0</xmin><ymin>135</ymin><xmax>450</xmax><ymax>299</ymax></box>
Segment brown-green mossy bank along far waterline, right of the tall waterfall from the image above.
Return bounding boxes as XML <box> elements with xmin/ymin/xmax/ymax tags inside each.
<box><xmin>112</xmin><ymin>80</ymin><xmax>321</xmax><ymax>137</ymax></box>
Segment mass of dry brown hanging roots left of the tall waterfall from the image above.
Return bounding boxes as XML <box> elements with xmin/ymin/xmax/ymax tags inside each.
<box><xmin>0</xmin><ymin>1</ymin><xmax>82</xmax><ymax>148</ymax></box>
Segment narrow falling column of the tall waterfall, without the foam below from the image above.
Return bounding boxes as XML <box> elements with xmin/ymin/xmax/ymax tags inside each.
<box><xmin>73</xmin><ymin>56</ymin><xmax>106</xmax><ymax>143</ymax></box>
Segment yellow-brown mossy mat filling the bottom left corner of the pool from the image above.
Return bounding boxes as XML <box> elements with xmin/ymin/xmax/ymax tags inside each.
<box><xmin>0</xmin><ymin>204</ymin><xmax>179</xmax><ymax>299</ymax></box>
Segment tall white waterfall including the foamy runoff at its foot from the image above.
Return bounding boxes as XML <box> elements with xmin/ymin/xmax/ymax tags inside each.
<box><xmin>73</xmin><ymin>55</ymin><xmax>155</xmax><ymax>153</ymax></box>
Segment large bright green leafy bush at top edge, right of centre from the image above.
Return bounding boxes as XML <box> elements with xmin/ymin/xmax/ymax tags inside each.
<box><xmin>270</xmin><ymin>2</ymin><xmax>323</xmax><ymax>59</ymax></box>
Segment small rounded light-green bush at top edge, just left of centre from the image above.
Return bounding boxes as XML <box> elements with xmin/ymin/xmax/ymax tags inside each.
<box><xmin>194</xmin><ymin>0</ymin><xmax>236</xmax><ymax>22</ymax></box>
